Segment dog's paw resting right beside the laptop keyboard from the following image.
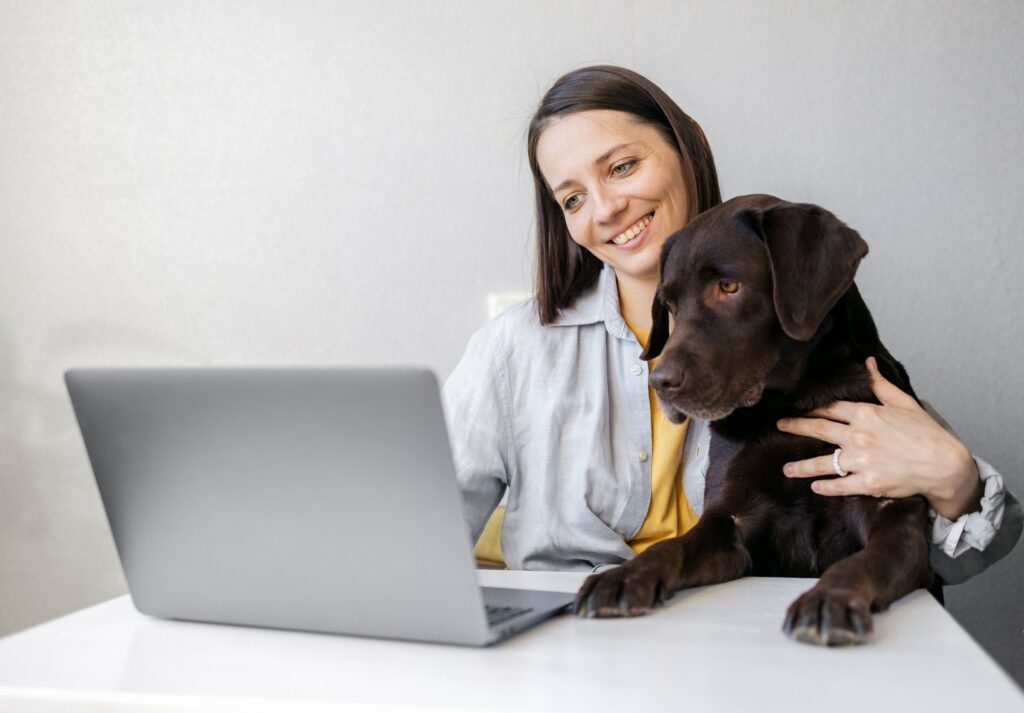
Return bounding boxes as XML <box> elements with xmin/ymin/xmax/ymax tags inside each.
<box><xmin>572</xmin><ymin>562</ymin><xmax>673</xmax><ymax>619</ymax></box>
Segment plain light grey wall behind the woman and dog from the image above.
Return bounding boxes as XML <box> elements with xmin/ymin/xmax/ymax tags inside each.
<box><xmin>0</xmin><ymin>0</ymin><xmax>1024</xmax><ymax>682</ymax></box>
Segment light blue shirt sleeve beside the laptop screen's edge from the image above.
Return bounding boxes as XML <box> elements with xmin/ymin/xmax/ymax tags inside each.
<box><xmin>441</xmin><ymin>325</ymin><xmax>510</xmax><ymax>542</ymax></box>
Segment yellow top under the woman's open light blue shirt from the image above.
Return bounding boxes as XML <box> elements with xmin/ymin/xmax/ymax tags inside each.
<box><xmin>474</xmin><ymin>324</ymin><xmax>697</xmax><ymax>563</ymax></box>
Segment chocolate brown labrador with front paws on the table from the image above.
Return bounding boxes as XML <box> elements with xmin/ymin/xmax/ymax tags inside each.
<box><xmin>575</xmin><ymin>190</ymin><xmax>933</xmax><ymax>645</ymax></box>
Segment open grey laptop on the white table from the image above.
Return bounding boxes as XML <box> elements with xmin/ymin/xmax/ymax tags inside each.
<box><xmin>65</xmin><ymin>369</ymin><xmax>573</xmax><ymax>645</ymax></box>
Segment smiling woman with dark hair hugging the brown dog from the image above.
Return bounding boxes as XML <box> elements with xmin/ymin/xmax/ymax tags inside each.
<box><xmin>444</xmin><ymin>67</ymin><xmax>1022</xmax><ymax>582</ymax></box>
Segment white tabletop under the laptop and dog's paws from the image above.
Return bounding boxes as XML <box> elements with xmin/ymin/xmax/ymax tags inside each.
<box><xmin>0</xmin><ymin>572</ymin><xmax>1024</xmax><ymax>713</ymax></box>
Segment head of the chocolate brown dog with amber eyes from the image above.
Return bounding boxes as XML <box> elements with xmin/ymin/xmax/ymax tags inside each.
<box><xmin>641</xmin><ymin>196</ymin><xmax>867</xmax><ymax>422</ymax></box>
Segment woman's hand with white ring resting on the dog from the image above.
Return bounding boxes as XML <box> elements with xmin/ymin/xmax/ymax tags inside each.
<box><xmin>778</xmin><ymin>357</ymin><xmax>983</xmax><ymax>519</ymax></box>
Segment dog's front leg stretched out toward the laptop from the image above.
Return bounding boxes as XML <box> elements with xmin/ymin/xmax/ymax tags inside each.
<box><xmin>573</xmin><ymin>511</ymin><xmax>751</xmax><ymax>618</ymax></box>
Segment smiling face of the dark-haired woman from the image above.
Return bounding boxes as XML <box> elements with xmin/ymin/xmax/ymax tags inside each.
<box><xmin>537</xmin><ymin>110</ymin><xmax>689</xmax><ymax>281</ymax></box>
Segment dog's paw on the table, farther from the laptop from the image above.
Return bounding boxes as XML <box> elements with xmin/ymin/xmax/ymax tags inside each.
<box><xmin>782</xmin><ymin>586</ymin><xmax>872</xmax><ymax>646</ymax></box>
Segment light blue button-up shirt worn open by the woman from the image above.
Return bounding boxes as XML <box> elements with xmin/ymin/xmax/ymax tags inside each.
<box><xmin>442</xmin><ymin>266</ymin><xmax>1022</xmax><ymax>582</ymax></box>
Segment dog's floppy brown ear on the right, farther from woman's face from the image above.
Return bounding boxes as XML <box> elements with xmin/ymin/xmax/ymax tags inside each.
<box><xmin>752</xmin><ymin>201</ymin><xmax>867</xmax><ymax>341</ymax></box>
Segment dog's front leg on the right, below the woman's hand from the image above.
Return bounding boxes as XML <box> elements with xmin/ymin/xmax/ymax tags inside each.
<box><xmin>782</xmin><ymin>498</ymin><xmax>934</xmax><ymax>646</ymax></box>
